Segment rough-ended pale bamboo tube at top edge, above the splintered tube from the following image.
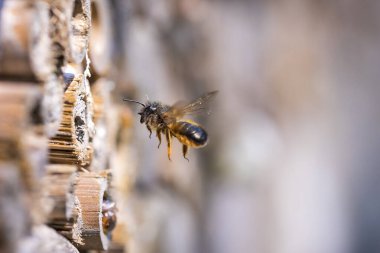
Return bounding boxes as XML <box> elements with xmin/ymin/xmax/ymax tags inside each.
<box><xmin>47</xmin><ymin>0</ymin><xmax>91</xmax><ymax>64</ymax></box>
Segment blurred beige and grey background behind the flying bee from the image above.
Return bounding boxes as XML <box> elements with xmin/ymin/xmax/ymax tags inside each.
<box><xmin>0</xmin><ymin>0</ymin><xmax>380</xmax><ymax>253</ymax></box>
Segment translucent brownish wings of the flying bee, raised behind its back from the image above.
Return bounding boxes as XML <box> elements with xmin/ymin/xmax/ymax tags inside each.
<box><xmin>164</xmin><ymin>91</ymin><xmax>218</xmax><ymax>123</ymax></box>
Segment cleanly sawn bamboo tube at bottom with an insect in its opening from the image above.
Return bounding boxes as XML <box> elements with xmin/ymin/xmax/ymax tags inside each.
<box><xmin>48</xmin><ymin>171</ymin><xmax>116</xmax><ymax>250</ymax></box>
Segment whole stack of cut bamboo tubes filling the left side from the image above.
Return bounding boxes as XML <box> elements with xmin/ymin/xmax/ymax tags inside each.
<box><xmin>0</xmin><ymin>0</ymin><xmax>132</xmax><ymax>252</ymax></box>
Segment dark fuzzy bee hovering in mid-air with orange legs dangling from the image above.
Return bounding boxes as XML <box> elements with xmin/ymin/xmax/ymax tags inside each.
<box><xmin>123</xmin><ymin>91</ymin><xmax>218</xmax><ymax>161</ymax></box>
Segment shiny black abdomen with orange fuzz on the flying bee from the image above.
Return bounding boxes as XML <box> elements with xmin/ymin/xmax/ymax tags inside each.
<box><xmin>170</xmin><ymin>121</ymin><xmax>207</xmax><ymax>148</ymax></box>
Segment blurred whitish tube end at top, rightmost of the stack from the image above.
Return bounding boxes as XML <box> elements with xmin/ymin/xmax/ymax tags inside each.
<box><xmin>89</xmin><ymin>0</ymin><xmax>114</xmax><ymax>77</ymax></box>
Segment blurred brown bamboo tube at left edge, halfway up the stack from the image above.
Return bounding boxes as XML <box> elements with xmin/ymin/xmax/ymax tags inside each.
<box><xmin>0</xmin><ymin>82</ymin><xmax>47</xmax><ymax>189</ymax></box>
